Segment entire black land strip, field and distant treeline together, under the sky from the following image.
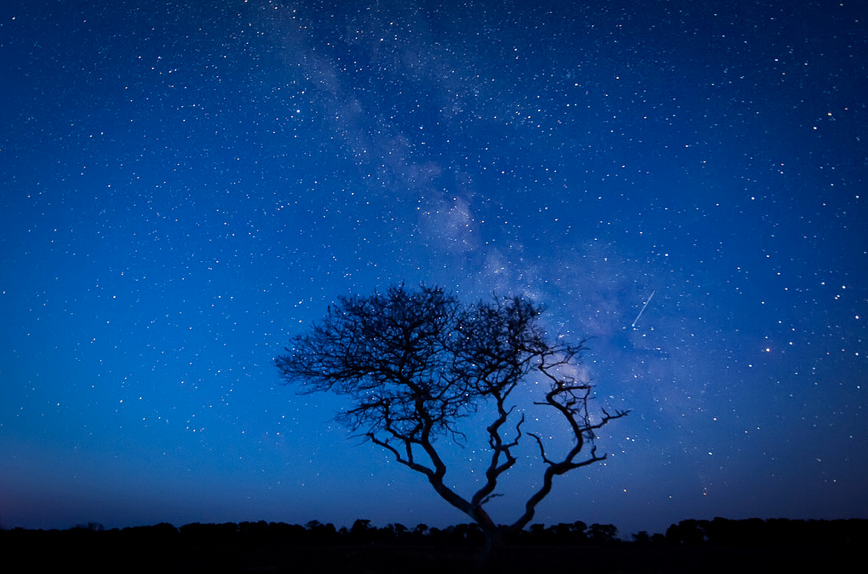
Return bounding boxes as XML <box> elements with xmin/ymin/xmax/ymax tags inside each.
<box><xmin>8</xmin><ymin>518</ymin><xmax>868</xmax><ymax>574</ymax></box>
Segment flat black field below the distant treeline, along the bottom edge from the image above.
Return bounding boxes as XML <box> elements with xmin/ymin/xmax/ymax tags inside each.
<box><xmin>0</xmin><ymin>536</ymin><xmax>866</xmax><ymax>574</ymax></box>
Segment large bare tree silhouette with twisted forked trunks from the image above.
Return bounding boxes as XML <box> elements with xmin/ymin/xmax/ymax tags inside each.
<box><xmin>275</xmin><ymin>285</ymin><xmax>628</xmax><ymax>550</ymax></box>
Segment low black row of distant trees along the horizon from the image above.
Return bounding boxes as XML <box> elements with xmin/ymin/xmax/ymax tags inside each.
<box><xmin>0</xmin><ymin>518</ymin><xmax>868</xmax><ymax>548</ymax></box>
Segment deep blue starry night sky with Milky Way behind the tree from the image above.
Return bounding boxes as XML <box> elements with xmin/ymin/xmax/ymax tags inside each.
<box><xmin>0</xmin><ymin>0</ymin><xmax>868</xmax><ymax>536</ymax></box>
